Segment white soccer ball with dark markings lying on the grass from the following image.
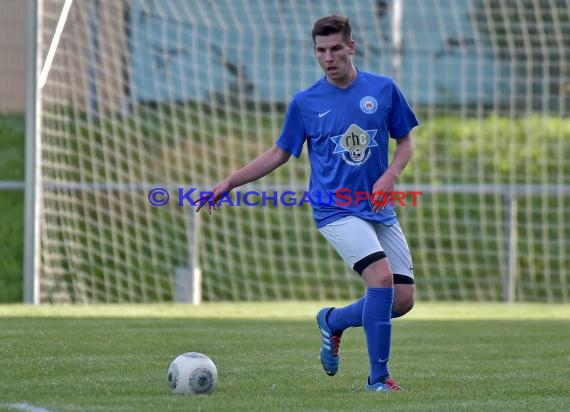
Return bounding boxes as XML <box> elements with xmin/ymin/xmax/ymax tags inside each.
<box><xmin>168</xmin><ymin>352</ymin><xmax>218</xmax><ymax>395</ymax></box>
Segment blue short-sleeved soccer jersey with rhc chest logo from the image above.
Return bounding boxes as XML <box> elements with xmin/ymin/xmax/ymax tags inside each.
<box><xmin>276</xmin><ymin>71</ymin><xmax>418</xmax><ymax>227</ymax></box>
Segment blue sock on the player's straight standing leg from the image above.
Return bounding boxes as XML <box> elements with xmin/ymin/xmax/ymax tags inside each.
<box><xmin>362</xmin><ymin>288</ymin><xmax>394</xmax><ymax>384</ymax></box>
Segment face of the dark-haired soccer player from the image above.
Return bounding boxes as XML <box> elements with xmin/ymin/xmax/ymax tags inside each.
<box><xmin>314</xmin><ymin>33</ymin><xmax>355</xmax><ymax>87</ymax></box>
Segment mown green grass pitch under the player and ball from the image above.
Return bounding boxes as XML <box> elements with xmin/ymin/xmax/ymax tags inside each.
<box><xmin>0</xmin><ymin>302</ymin><xmax>570</xmax><ymax>412</ymax></box>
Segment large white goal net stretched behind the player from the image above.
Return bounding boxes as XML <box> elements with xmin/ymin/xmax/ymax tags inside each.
<box><xmin>26</xmin><ymin>0</ymin><xmax>570</xmax><ymax>302</ymax></box>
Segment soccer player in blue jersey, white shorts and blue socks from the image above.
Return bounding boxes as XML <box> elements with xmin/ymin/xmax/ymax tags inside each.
<box><xmin>196</xmin><ymin>15</ymin><xmax>418</xmax><ymax>392</ymax></box>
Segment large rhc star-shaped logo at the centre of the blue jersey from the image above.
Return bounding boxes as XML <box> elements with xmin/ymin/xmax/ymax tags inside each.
<box><xmin>331</xmin><ymin>124</ymin><xmax>378</xmax><ymax>166</ymax></box>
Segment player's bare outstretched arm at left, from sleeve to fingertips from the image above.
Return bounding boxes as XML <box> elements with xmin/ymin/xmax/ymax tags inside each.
<box><xmin>196</xmin><ymin>144</ymin><xmax>291</xmax><ymax>213</ymax></box>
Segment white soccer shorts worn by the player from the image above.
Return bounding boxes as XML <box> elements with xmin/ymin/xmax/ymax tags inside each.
<box><xmin>319</xmin><ymin>216</ymin><xmax>414</xmax><ymax>279</ymax></box>
